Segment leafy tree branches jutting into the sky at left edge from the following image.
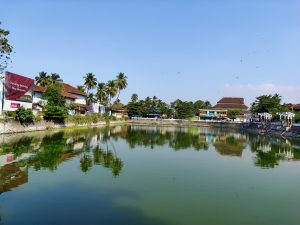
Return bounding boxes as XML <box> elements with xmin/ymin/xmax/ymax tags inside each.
<box><xmin>0</xmin><ymin>22</ymin><xmax>13</xmax><ymax>73</ymax></box>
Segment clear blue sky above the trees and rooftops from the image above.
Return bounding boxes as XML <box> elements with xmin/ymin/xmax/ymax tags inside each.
<box><xmin>0</xmin><ymin>0</ymin><xmax>300</xmax><ymax>104</ymax></box>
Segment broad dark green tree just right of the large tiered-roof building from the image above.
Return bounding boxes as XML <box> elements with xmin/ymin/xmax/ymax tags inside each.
<box><xmin>250</xmin><ymin>94</ymin><xmax>288</xmax><ymax>115</ymax></box>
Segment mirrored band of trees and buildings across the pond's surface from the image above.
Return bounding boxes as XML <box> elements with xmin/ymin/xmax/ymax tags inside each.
<box><xmin>0</xmin><ymin>126</ymin><xmax>300</xmax><ymax>193</ymax></box>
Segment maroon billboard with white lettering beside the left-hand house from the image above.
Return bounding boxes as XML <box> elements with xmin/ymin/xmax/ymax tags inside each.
<box><xmin>4</xmin><ymin>72</ymin><xmax>34</xmax><ymax>102</ymax></box>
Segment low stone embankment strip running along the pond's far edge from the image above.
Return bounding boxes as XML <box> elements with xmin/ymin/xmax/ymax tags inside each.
<box><xmin>0</xmin><ymin>119</ymin><xmax>300</xmax><ymax>138</ymax></box>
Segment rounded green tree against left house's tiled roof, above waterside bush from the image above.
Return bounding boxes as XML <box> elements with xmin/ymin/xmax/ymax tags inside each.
<box><xmin>42</xmin><ymin>83</ymin><xmax>65</xmax><ymax>107</ymax></box>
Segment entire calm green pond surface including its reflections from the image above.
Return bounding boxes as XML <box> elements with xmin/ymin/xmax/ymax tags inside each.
<box><xmin>0</xmin><ymin>126</ymin><xmax>300</xmax><ymax>225</ymax></box>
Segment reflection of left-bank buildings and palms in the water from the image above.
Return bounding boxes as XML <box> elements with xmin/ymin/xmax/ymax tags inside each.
<box><xmin>0</xmin><ymin>129</ymin><xmax>123</xmax><ymax>193</ymax></box>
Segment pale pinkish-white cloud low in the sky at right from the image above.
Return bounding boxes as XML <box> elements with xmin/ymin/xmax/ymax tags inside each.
<box><xmin>224</xmin><ymin>83</ymin><xmax>300</xmax><ymax>104</ymax></box>
